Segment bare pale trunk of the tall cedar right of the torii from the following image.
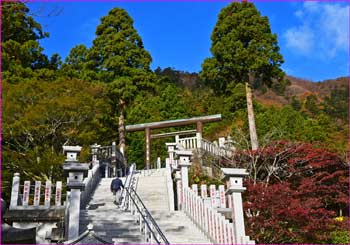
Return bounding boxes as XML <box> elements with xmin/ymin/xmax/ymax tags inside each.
<box><xmin>245</xmin><ymin>82</ymin><xmax>259</xmax><ymax>150</ymax></box>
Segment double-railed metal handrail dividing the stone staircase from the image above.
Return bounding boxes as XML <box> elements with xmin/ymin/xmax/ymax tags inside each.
<box><xmin>125</xmin><ymin>188</ymin><xmax>170</xmax><ymax>244</ymax></box>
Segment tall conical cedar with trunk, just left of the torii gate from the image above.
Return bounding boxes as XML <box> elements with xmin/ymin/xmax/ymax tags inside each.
<box><xmin>86</xmin><ymin>8</ymin><xmax>152</xmax><ymax>159</ymax></box>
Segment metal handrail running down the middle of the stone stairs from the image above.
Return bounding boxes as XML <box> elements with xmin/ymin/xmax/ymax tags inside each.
<box><xmin>124</xmin><ymin>188</ymin><xmax>170</xmax><ymax>244</ymax></box>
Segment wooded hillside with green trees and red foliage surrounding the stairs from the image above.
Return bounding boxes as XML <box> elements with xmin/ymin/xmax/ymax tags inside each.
<box><xmin>1</xmin><ymin>2</ymin><xmax>349</xmax><ymax>243</ymax></box>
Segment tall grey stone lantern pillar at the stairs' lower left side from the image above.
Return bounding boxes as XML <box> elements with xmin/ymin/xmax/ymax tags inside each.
<box><xmin>63</xmin><ymin>146</ymin><xmax>89</xmax><ymax>240</ymax></box>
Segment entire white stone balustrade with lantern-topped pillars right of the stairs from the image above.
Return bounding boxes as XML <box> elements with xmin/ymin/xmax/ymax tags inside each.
<box><xmin>166</xmin><ymin>135</ymin><xmax>255</xmax><ymax>244</ymax></box>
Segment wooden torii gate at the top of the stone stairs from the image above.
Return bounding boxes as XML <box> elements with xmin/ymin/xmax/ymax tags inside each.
<box><xmin>125</xmin><ymin>114</ymin><xmax>221</xmax><ymax>169</ymax></box>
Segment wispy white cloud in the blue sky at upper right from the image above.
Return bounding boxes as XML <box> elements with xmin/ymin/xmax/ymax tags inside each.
<box><xmin>283</xmin><ymin>2</ymin><xmax>349</xmax><ymax>59</ymax></box>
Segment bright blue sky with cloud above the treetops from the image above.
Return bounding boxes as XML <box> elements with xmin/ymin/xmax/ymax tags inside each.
<box><xmin>27</xmin><ymin>0</ymin><xmax>349</xmax><ymax>81</ymax></box>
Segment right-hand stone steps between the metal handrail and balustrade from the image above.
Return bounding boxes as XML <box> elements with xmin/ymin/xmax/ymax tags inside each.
<box><xmin>136</xmin><ymin>169</ymin><xmax>211</xmax><ymax>244</ymax></box>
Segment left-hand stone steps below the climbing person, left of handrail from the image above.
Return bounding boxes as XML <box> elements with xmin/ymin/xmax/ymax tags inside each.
<box><xmin>79</xmin><ymin>178</ymin><xmax>145</xmax><ymax>244</ymax></box>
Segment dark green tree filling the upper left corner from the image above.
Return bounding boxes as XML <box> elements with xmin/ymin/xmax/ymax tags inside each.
<box><xmin>1</xmin><ymin>1</ymin><xmax>60</xmax><ymax>82</ymax></box>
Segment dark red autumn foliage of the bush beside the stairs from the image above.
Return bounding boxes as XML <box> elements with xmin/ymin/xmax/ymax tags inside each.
<box><xmin>236</xmin><ymin>142</ymin><xmax>349</xmax><ymax>243</ymax></box>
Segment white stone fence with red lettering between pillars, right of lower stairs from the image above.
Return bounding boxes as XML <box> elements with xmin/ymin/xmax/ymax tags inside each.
<box><xmin>181</xmin><ymin>184</ymin><xmax>254</xmax><ymax>244</ymax></box>
